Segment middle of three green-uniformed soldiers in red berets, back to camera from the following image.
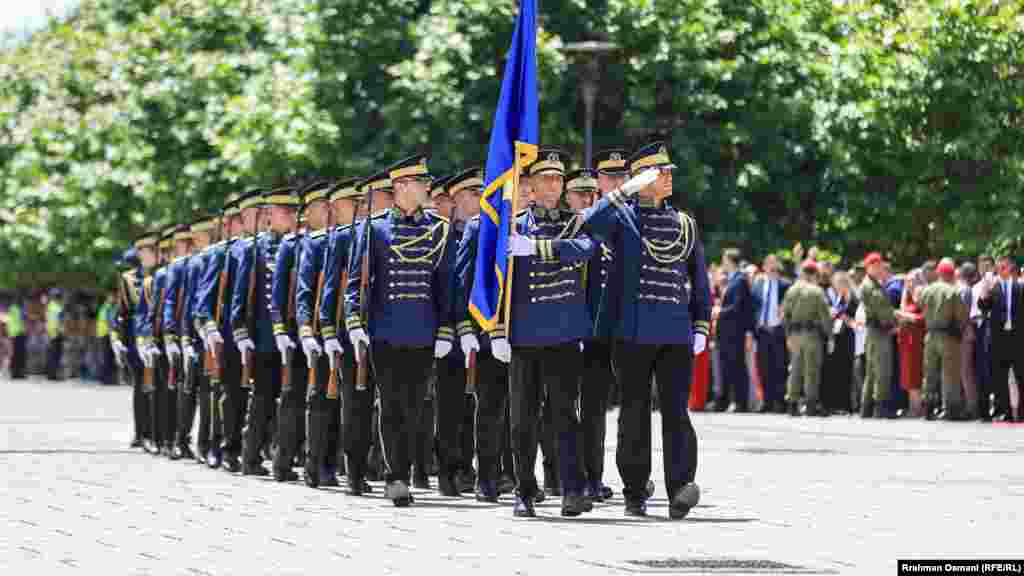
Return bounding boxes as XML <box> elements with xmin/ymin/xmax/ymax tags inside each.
<box><xmin>860</xmin><ymin>252</ymin><xmax>896</xmax><ymax>418</ymax></box>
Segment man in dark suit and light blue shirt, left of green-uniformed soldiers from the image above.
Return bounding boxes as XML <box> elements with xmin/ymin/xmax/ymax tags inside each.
<box><xmin>753</xmin><ymin>254</ymin><xmax>792</xmax><ymax>414</ymax></box>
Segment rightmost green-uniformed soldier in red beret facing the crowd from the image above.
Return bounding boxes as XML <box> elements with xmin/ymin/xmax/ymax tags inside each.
<box><xmin>918</xmin><ymin>258</ymin><xmax>967</xmax><ymax>420</ymax></box>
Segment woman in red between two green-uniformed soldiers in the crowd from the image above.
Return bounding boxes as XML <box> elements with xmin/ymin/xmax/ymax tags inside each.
<box><xmin>896</xmin><ymin>269</ymin><xmax>928</xmax><ymax>418</ymax></box>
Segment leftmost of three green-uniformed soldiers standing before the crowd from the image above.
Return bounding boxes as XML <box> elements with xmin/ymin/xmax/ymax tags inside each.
<box><xmin>782</xmin><ymin>260</ymin><xmax>831</xmax><ymax>416</ymax></box>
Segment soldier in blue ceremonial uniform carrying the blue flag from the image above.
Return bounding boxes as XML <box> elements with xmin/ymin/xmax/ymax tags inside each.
<box><xmin>492</xmin><ymin>148</ymin><xmax>594</xmax><ymax>518</ymax></box>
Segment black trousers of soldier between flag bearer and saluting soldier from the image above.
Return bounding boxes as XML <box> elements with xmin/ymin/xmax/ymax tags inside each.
<box><xmin>580</xmin><ymin>340</ymin><xmax>615</xmax><ymax>487</ymax></box>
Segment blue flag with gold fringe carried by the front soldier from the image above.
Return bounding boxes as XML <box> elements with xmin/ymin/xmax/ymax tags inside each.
<box><xmin>469</xmin><ymin>0</ymin><xmax>540</xmax><ymax>330</ymax></box>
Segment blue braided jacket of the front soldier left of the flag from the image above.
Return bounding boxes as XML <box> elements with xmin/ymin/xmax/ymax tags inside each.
<box><xmin>345</xmin><ymin>208</ymin><xmax>455</xmax><ymax>347</ymax></box>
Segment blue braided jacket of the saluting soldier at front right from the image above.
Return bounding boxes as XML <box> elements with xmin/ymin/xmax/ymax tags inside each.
<box><xmin>586</xmin><ymin>193</ymin><xmax>711</xmax><ymax>344</ymax></box>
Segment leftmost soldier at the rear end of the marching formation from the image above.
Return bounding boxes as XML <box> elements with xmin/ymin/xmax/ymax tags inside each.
<box><xmin>111</xmin><ymin>239</ymin><xmax>154</xmax><ymax>448</ymax></box>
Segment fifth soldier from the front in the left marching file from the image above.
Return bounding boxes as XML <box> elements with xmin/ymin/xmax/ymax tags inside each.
<box><xmin>231</xmin><ymin>188</ymin><xmax>299</xmax><ymax>473</ymax></box>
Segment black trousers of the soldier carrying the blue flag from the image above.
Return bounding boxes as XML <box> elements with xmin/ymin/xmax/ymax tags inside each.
<box><xmin>509</xmin><ymin>342</ymin><xmax>583</xmax><ymax>498</ymax></box>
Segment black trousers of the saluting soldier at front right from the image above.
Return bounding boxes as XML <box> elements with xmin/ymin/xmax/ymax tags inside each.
<box><xmin>613</xmin><ymin>341</ymin><xmax>697</xmax><ymax>499</ymax></box>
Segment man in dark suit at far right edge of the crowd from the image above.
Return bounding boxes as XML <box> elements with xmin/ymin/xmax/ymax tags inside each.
<box><xmin>978</xmin><ymin>257</ymin><xmax>1024</xmax><ymax>421</ymax></box>
